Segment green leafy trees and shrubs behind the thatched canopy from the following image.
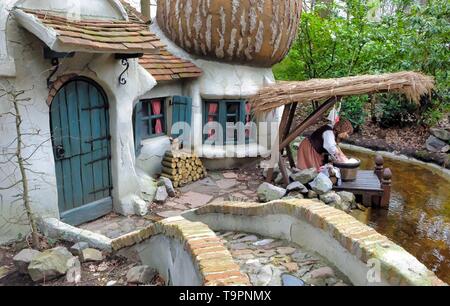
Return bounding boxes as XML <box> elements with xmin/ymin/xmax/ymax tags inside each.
<box><xmin>274</xmin><ymin>0</ymin><xmax>450</xmax><ymax>126</ymax></box>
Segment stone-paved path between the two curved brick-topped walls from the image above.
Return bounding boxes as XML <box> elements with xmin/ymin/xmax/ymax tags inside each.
<box><xmin>216</xmin><ymin>232</ymin><xmax>351</xmax><ymax>286</ymax></box>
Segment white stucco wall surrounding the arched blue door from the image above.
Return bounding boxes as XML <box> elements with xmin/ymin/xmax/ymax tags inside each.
<box><xmin>0</xmin><ymin>7</ymin><xmax>156</xmax><ymax>243</ymax></box>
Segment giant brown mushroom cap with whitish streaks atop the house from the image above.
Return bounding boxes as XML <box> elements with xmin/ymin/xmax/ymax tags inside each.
<box><xmin>157</xmin><ymin>0</ymin><xmax>302</xmax><ymax>67</ymax></box>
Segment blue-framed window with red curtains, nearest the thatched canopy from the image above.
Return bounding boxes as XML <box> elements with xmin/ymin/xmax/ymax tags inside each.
<box><xmin>203</xmin><ymin>100</ymin><xmax>256</xmax><ymax>144</ymax></box>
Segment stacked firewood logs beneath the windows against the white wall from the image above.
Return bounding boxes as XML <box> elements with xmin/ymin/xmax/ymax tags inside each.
<box><xmin>162</xmin><ymin>151</ymin><xmax>206</xmax><ymax>188</ymax></box>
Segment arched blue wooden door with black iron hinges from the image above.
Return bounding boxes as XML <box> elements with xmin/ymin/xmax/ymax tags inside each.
<box><xmin>51</xmin><ymin>78</ymin><xmax>112</xmax><ymax>225</ymax></box>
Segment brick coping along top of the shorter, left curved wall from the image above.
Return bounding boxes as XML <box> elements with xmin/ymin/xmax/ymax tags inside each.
<box><xmin>111</xmin><ymin>217</ymin><xmax>250</xmax><ymax>286</ymax></box>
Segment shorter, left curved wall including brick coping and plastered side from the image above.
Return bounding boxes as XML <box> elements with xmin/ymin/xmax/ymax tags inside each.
<box><xmin>111</xmin><ymin>217</ymin><xmax>250</xmax><ymax>286</ymax></box>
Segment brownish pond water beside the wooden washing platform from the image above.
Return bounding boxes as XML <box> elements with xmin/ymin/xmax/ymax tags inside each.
<box><xmin>346</xmin><ymin>151</ymin><xmax>450</xmax><ymax>284</ymax></box>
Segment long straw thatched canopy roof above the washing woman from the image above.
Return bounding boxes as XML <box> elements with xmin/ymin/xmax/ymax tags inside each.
<box><xmin>249</xmin><ymin>72</ymin><xmax>434</xmax><ymax>113</ymax></box>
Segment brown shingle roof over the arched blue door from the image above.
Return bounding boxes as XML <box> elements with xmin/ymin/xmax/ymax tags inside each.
<box><xmin>21</xmin><ymin>9</ymin><xmax>164</xmax><ymax>53</ymax></box>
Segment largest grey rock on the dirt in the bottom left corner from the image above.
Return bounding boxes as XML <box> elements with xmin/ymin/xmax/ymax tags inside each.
<box><xmin>28</xmin><ymin>247</ymin><xmax>73</xmax><ymax>282</ymax></box>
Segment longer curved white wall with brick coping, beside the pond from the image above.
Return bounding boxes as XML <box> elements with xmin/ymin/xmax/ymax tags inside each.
<box><xmin>184</xmin><ymin>200</ymin><xmax>446</xmax><ymax>285</ymax></box>
